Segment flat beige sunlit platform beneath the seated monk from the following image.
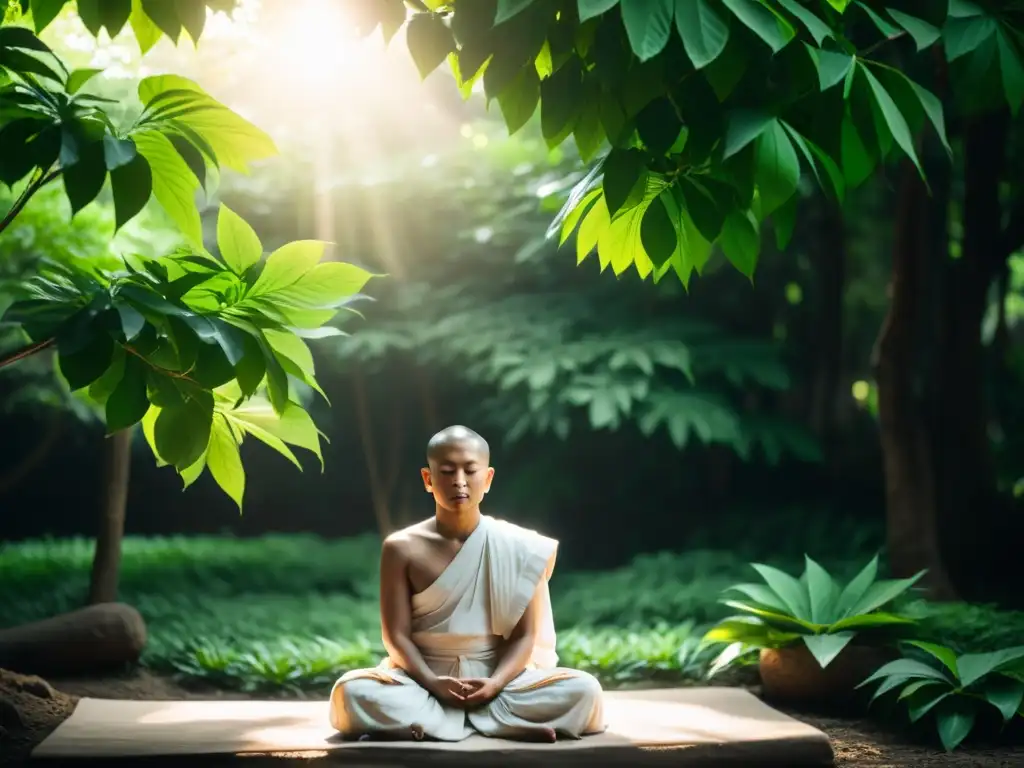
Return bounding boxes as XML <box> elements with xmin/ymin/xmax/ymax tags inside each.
<box><xmin>32</xmin><ymin>687</ymin><xmax>835</xmax><ymax>766</ymax></box>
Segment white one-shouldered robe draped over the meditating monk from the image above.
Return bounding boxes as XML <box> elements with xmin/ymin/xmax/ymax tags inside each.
<box><xmin>330</xmin><ymin>515</ymin><xmax>605</xmax><ymax>741</ymax></box>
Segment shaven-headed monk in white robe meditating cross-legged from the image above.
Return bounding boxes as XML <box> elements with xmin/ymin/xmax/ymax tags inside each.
<box><xmin>330</xmin><ymin>426</ymin><xmax>605</xmax><ymax>741</ymax></box>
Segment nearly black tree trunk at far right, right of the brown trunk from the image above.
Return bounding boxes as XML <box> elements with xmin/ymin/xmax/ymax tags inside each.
<box><xmin>933</xmin><ymin>114</ymin><xmax>1009</xmax><ymax>598</ymax></box>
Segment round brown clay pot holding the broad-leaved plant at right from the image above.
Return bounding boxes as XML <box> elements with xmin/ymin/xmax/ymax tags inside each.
<box><xmin>759</xmin><ymin>643</ymin><xmax>895</xmax><ymax>706</ymax></box>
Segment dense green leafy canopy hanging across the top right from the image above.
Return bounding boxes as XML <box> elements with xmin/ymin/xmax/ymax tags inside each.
<box><xmin>352</xmin><ymin>0</ymin><xmax>1024</xmax><ymax>285</ymax></box>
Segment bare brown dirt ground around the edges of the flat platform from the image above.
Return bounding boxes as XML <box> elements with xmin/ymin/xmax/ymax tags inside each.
<box><xmin>0</xmin><ymin>670</ymin><xmax>1024</xmax><ymax>768</ymax></box>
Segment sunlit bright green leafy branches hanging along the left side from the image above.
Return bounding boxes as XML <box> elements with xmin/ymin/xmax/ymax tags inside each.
<box><xmin>0</xmin><ymin>10</ymin><xmax>380</xmax><ymax>510</ymax></box>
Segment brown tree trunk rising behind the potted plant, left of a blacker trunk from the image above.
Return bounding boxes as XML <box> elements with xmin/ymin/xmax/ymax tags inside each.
<box><xmin>872</xmin><ymin>163</ymin><xmax>955</xmax><ymax>599</ymax></box>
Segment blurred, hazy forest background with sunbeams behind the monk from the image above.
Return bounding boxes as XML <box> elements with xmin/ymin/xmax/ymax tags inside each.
<box><xmin>0</xmin><ymin>1</ymin><xmax>1024</xmax><ymax>581</ymax></box>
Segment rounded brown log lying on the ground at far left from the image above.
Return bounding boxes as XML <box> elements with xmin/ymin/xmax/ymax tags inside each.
<box><xmin>0</xmin><ymin>603</ymin><xmax>145</xmax><ymax>676</ymax></box>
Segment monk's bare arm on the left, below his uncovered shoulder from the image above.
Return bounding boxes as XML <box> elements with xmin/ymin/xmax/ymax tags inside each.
<box><xmin>381</xmin><ymin>538</ymin><xmax>437</xmax><ymax>691</ymax></box>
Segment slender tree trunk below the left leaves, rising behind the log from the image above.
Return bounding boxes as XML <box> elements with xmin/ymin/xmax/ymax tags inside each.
<box><xmin>89</xmin><ymin>429</ymin><xmax>132</xmax><ymax>605</ymax></box>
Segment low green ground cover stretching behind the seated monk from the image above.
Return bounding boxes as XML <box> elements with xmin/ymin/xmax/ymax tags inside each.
<box><xmin>0</xmin><ymin>521</ymin><xmax>1024</xmax><ymax>691</ymax></box>
